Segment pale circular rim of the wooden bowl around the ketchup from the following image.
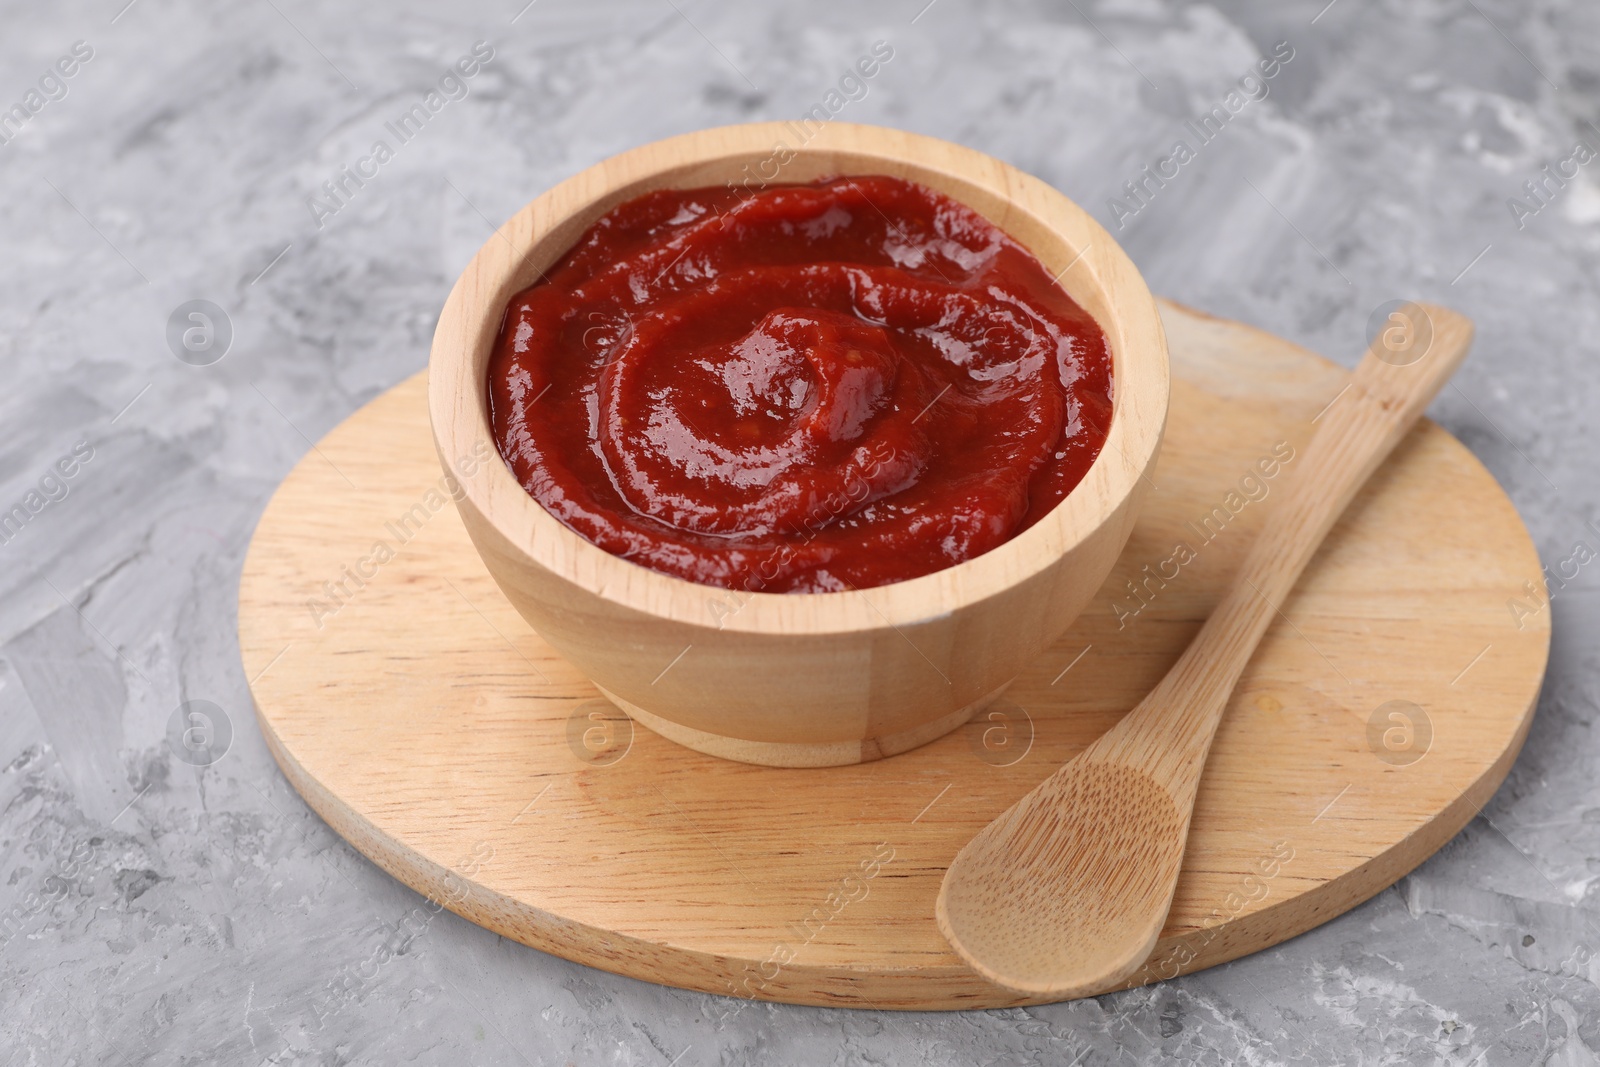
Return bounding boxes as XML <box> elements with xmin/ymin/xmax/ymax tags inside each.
<box><xmin>427</xmin><ymin>122</ymin><xmax>1171</xmax><ymax>640</ymax></box>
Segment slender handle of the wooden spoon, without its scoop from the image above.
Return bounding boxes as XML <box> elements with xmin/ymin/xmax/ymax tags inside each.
<box><xmin>1085</xmin><ymin>304</ymin><xmax>1472</xmax><ymax>797</ymax></box>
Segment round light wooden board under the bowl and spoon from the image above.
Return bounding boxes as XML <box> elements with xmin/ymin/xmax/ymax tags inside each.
<box><xmin>238</xmin><ymin>304</ymin><xmax>1549</xmax><ymax>1013</ymax></box>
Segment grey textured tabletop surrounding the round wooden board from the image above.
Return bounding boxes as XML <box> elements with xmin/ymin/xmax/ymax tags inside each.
<box><xmin>0</xmin><ymin>0</ymin><xmax>1600</xmax><ymax>1065</ymax></box>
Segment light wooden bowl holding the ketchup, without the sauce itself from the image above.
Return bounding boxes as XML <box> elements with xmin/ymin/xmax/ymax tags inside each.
<box><xmin>429</xmin><ymin>123</ymin><xmax>1168</xmax><ymax>766</ymax></box>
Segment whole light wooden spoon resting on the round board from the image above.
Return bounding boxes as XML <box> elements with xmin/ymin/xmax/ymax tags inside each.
<box><xmin>936</xmin><ymin>304</ymin><xmax>1472</xmax><ymax>998</ymax></box>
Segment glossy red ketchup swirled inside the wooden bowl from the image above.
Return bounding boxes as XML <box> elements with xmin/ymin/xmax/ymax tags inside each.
<box><xmin>488</xmin><ymin>178</ymin><xmax>1112</xmax><ymax>592</ymax></box>
